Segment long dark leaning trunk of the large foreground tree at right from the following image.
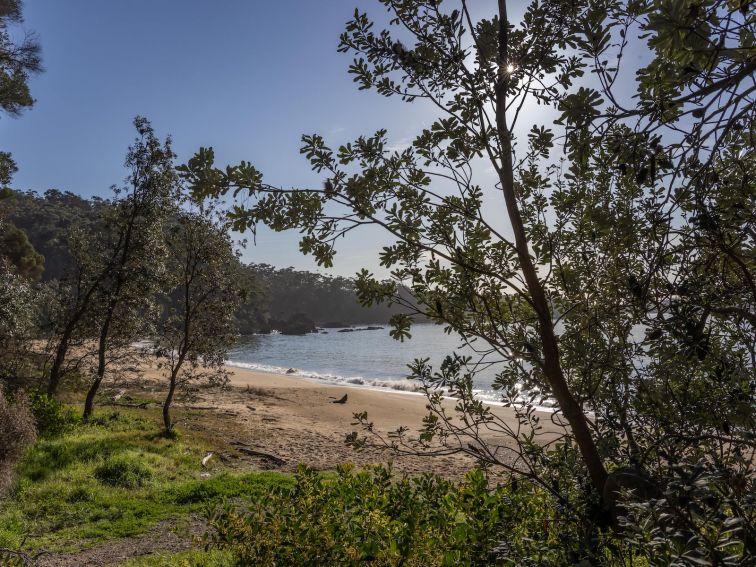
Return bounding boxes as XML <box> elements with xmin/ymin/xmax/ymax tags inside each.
<box><xmin>496</xmin><ymin>0</ymin><xmax>607</xmax><ymax>494</ymax></box>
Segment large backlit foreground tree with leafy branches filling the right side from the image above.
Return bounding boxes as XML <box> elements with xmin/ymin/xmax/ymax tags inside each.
<box><xmin>181</xmin><ymin>0</ymin><xmax>756</xmax><ymax>561</ymax></box>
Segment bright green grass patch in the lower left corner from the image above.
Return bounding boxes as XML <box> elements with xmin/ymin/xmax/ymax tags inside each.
<box><xmin>0</xmin><ymin>410</ymin><xmax>292</xmax><ymax>556</ymax></box>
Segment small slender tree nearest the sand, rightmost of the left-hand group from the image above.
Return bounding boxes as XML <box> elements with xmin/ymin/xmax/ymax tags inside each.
<box><xmin>155</xmin><ymin>207</ymin><xmax>244</xmax><ymax>435</ymax></box>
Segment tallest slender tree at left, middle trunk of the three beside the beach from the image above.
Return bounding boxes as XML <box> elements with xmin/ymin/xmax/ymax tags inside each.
<box><xmin>84</xmin><ymin>117</ymin><xmax>178</xmax><ymax>418</ymax></box>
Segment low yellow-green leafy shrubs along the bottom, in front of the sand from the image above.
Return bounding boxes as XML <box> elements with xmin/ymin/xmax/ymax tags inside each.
<box><xmin>206</xmin><ymin>466</ymin><xmax>636</xmax><ymax>567</ymax></box>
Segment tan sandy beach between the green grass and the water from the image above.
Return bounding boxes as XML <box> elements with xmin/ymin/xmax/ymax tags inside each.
<box><xmin>134</xmin><ymin>367</ymin><xmax>560</xmax><ymax>477</ymax></box>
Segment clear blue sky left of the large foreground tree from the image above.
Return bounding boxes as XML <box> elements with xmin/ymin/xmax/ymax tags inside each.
<box><xmin>0</xmin><ymin>0</ymin><xmax>532</xmax><ymax>275</ymax></box>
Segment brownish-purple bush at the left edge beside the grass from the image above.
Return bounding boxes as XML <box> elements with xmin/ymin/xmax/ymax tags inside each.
<box><xmin>0</xmin><ymin>389</ymin><xmax>36</xmax><ymax>495</ymax></box>
